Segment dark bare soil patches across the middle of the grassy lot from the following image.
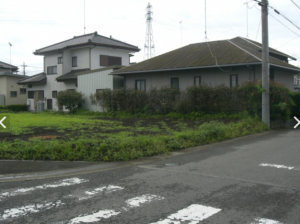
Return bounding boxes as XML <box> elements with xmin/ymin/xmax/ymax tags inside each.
<box><xmin>0</xmin><ymin>117</ymin><xmax>233</xmax><ymax>141</ymax></box>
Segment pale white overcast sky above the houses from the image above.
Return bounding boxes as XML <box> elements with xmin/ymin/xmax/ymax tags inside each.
<box><xmin>0</xmin><ymin>0</ymin><xmax>300</xmax><ymax>75</ymax></box>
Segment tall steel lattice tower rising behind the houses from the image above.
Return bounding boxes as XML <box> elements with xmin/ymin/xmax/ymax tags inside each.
<box><xmin>144</xmin><ymin>2</ymin><xmax>155</xmax><ymax>59</ymax></box>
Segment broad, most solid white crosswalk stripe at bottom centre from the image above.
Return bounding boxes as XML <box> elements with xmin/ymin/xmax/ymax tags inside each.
<box><xmin>151</xmin><ymin>204</ymin><xmax>221</xmax><ymax>224</ymax></box>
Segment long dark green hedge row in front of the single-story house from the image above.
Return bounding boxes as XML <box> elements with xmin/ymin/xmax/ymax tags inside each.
<box><xmin>90</xmin><ymin>82</ymin><xmax>300</xmax><ymax>120</ymax></box>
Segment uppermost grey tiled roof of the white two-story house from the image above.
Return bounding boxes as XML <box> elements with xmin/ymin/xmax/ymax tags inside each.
<box><xmin>34</xmin><ymin>32</ymin><xmax>140</xmax><ymax>55</ymax></box>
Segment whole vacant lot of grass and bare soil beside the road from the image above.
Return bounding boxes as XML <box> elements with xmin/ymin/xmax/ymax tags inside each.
<box><xmin>0</xmin><ymin>112</ymin><xmax>267</xmax><ymax>161</ymax></box>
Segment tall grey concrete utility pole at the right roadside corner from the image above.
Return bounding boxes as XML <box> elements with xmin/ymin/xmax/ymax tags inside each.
<box><xmin>259</xmin><ymin>0</ymin><xmax>270</xmax><ymax>127</ymax></box>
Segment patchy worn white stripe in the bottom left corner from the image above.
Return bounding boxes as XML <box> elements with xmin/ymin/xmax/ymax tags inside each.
<box><xmin>0</xmin><ymin>201</ymin><xmax>64</xmax><ymax>221</ymax></box>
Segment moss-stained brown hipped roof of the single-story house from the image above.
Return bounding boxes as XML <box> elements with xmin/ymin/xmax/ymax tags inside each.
<box><xmin>112</xmin><ymin>37</ymin><xmax>300</xmax><ymax>74</ymax></box>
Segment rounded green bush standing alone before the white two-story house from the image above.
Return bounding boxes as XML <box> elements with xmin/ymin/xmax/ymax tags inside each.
<box><xmin>56</xmin><ymin>90</ymin><xmax>84</xmax><ymax>113</ymax></box>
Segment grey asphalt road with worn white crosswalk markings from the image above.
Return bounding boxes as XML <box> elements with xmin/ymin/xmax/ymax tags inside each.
<box><xmin>0</xmin><ymin>129</ymin><xmax>300</xmax><ymax>224</ymax></box>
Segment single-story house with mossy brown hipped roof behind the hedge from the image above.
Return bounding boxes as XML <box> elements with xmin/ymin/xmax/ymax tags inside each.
<box><xmin>111</xmin><ymin>37</ymin><xmax>300</xmax><ymax>91</ymax></box>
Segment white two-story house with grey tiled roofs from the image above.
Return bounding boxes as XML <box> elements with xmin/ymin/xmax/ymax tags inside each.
<box><xmin>18</xmin><ymin>32</ymin><xmax>140</xmax><ymax>110</ymax></box>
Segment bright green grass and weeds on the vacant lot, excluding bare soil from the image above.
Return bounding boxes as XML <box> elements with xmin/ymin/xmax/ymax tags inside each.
<box><xmin>0</xmin><ymin>112</ymin><xmax>267</xmax><ymax>161</ymax></box>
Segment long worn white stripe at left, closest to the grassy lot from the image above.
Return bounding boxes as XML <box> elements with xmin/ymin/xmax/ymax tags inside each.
<box><xmin>0</xmin><ymin>177</ymin><xmax>88</xmax><ymax>201</ymax></box>
